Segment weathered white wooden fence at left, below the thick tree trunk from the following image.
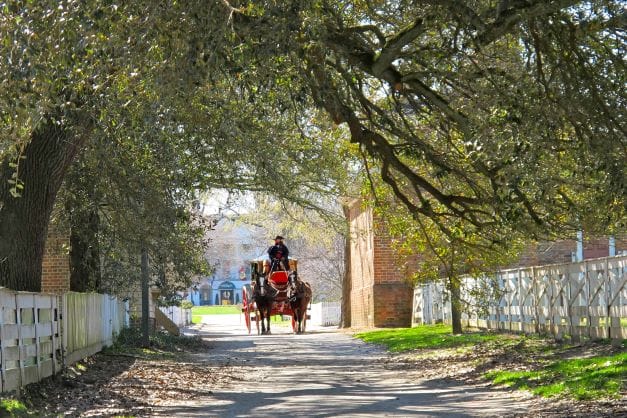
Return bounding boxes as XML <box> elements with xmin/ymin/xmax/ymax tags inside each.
<box><xmin>0</xmin><ymin>288</ymin><xmax>128</xmax><ymax>392</ymax></box>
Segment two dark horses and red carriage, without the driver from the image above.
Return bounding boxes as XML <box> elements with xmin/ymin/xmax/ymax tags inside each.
<box><xmin>242</xmin><ymin>259</ymin><xmax>311</xmax><ymax>334</ymax></box>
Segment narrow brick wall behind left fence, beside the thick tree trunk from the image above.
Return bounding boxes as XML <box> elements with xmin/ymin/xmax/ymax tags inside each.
<box><xmin>41</xmin><ymin>231</ymin><xmax>70</xmax><ymax>294</ymax></box>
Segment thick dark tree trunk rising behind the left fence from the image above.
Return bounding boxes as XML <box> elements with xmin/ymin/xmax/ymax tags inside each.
<box><xmin>0</xmin><ymin>121</ymin><xmax>86</xmax><ymax>292</ymax></box>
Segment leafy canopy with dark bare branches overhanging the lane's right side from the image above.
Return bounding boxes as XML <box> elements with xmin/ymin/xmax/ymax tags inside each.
<box><xmin>223</xmin><ymin>1</ymin><xmax>627</xmax><ymax>241</ymax></box>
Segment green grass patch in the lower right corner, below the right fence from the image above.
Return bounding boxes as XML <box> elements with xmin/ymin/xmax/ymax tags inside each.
<box><xmin>485</xmin><ymin>353</ymin><xmax>627</xmax><ymax>400</ymax></box>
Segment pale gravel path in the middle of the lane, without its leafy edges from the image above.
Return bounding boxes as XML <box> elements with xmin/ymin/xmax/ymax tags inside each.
<box><xmin>154</xmin><ymin>315</ymin><xmax>527</xmax><ymax>417</ymax></box>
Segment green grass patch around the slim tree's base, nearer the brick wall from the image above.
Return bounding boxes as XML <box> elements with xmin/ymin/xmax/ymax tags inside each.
<box><xmin>355</xmin><ymin>324</ymin><xmax>511</xmax><ymax>352</ymax></box>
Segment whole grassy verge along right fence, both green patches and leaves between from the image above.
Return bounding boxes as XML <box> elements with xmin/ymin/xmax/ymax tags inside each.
<box><xmin>355</xmin><ymin>325</ymin><xmax>627</xmax><ymax>400</ymax></box>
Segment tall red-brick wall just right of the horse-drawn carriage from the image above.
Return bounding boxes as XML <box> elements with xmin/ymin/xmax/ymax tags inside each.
<box><xmin>349</xmin><ymin>200</ymin><xmax>413</xmax><ymax>328</ymax></box>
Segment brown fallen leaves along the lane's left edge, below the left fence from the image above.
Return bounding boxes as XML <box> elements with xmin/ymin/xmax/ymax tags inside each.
<box><xmin>24</xmin><ymin>354</ymin><xmax>235</xmax><ymax>417</ymax></box>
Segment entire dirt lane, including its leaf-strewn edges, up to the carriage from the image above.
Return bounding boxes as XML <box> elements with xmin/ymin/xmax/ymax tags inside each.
<box><xmin>22</xmin><ymin>315</ymin><xmax>627</xmax><ymax>417</ymax></box>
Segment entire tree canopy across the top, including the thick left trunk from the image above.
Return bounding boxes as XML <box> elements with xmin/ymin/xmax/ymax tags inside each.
<box><xmin>0</xmin><ymin>0</ymin><xmax>627</xmax><ymax>289</ymax></box>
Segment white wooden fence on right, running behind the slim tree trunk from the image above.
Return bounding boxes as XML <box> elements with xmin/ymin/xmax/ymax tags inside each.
<box><xmin>413</xmin><ymin>255</ymin><xmax>627</xmax><ymax>341</ymax></box>
